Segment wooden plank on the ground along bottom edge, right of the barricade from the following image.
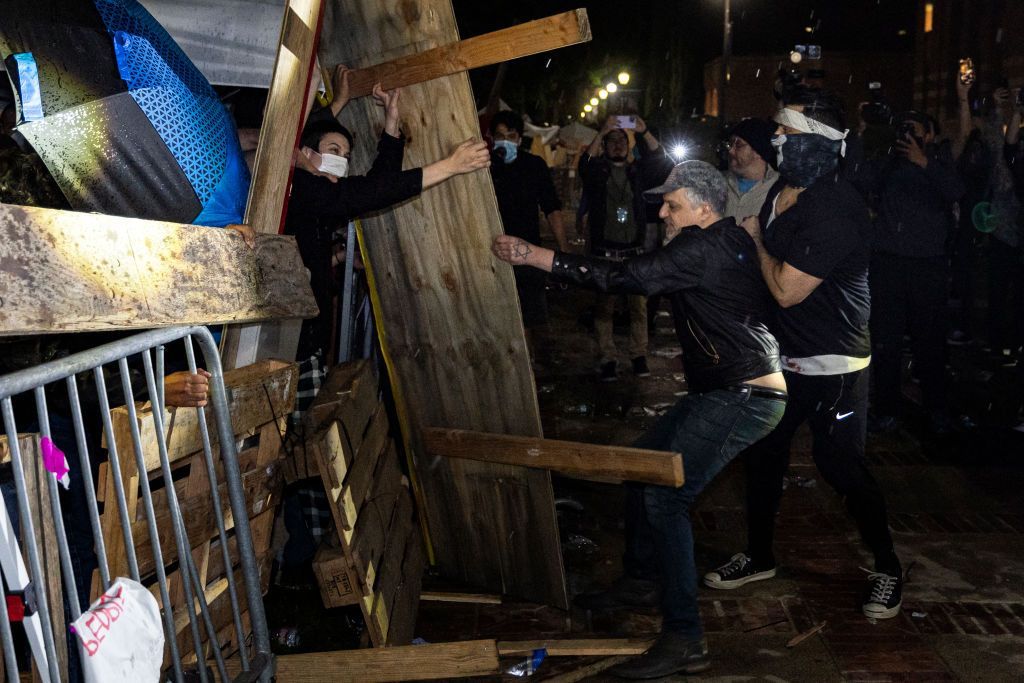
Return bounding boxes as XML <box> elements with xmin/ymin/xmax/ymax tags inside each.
<box><xmin>226</xmin><ymin>640</ymin><xmax>500</xmax><ymax>683</ymax></box>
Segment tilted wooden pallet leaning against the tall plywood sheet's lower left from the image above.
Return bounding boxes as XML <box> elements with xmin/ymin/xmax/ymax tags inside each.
<box><xmin>306</xmin><ymin>360</ymin><xmax>425</xmax><ymax>647</ymax></box>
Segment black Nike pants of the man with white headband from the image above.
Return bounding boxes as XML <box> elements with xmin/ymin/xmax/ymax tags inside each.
<box><xmin>742</xmin><ymin>369</ymin><xmax>901</xmax><ymax>575</ymax></box>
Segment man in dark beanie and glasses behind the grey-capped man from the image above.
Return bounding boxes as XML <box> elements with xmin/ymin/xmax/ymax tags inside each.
<box><xmin>725</xmin><ymin>119</ymin><xmax>778</xmax><ymax>220</ymax></box>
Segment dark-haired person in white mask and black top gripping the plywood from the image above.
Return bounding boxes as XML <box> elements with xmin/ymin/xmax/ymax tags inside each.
<box><xmin>285</xmin><ymin>79</ymin><xmax>490</xmax><ymax>372</ymax></box>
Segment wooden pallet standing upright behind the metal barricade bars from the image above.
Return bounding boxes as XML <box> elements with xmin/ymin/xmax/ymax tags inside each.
<box><xmin>93</xmin><ymin>360</ymin><xmax>298</xmax><ymax>664</ymax></box>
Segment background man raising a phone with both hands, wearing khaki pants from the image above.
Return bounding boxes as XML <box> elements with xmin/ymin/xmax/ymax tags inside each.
<box><xmin>580</xmin><ymin>116</ymin><xmax>672</xmax><ymax>382</ymax></box>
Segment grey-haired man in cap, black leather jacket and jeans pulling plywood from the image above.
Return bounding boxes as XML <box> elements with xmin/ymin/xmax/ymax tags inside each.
<box><xmin>494</xmin><ymin>161</ymin><xmax>786</xmax><ymax>678</ymax></box>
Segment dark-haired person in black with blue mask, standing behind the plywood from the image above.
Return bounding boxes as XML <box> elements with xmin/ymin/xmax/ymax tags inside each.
<box><xmin>489</xmin><ymin>112</ymin><xmax>569</xmax><ymax>360</ymax></box>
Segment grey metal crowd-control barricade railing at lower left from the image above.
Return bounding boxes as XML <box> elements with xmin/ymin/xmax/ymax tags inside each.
<box><xmin>0</xmin><ymin>327</ymin><xmax>273</xmax><ymax>683</ymax></box>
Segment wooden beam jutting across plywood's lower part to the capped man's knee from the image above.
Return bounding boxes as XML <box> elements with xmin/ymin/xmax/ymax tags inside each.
<box><xmin>423</xmin><ymin>428</ymin><xmax>683</xmax><ymax>486</ymax></box>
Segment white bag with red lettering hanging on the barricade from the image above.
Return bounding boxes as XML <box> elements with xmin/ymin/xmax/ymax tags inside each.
<box><xmin>72</xmin><ymin>578</ymin><xmax>164</xmax><ymax>683</ymax></box>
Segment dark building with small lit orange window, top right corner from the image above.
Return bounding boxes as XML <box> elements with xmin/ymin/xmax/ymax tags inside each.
<box><xmin>913</xmin><ymin>0</ymin><xmax>1024</xmax><ymax>123</ymax></box>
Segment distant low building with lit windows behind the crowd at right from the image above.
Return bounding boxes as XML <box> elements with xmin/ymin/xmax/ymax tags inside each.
<box><xmin>703</xmin><ymin>51</ymin><xmax>913</xmax><ymax>128</ymax></box>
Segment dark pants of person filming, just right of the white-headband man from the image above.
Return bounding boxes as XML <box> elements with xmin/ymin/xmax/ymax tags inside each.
<box><xmin>870</xmin><ymin>254</ymin><xmax>949</xmax><ymax>416</ymax></box>
